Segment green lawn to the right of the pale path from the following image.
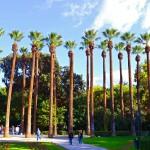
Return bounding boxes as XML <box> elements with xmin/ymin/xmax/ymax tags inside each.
<box><xmin>83</xmin><ymin>136</ymin><xmax>135</xmax><ymax>150</ymax></box>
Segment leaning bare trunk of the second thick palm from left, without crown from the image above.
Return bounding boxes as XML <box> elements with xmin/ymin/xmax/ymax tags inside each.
<box><xmin>25</xmin><ymin>45</ymin><xmax>37</xmax><ymax>138</ymax></box>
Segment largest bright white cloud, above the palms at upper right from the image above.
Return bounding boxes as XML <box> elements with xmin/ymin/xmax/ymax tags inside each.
<box><xmin>92</xmin><ymin>0</ymin><xmax>149</xmax><ymax>31</ymax></box>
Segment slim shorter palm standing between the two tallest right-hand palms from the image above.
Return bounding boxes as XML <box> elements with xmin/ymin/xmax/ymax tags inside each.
<box><xmin>98</xmin><ymin>40</ymin><xmax>107</xmax><ymax>131</ymax></box>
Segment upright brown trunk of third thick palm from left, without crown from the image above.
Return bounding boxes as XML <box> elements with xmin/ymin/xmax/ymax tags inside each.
<box><xmin>48</xmin><ymin>46</ymin><xmax>55</xmax><ymax>137</ymax></box>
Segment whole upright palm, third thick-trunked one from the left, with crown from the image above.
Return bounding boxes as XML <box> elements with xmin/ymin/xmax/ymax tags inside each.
<box><xmin>45</xmin><ymin>32</ymin><xmax>62</xmax><ymax>137</ymax></box>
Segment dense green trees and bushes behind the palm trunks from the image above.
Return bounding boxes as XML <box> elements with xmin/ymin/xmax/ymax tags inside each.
<box><xmin>0</xmin><ymin>54</ymin><xmax>150</xmax><ymax>133</ymax></box>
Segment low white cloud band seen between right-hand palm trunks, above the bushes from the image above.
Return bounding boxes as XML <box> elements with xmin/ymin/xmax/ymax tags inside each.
<box><xmin>94</xmin><ymin>69</ymin><xmax>134</xmax><ymax>87</ymax></box>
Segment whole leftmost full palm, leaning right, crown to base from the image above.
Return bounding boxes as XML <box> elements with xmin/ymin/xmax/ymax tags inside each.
<box><xmin>4</xmin><ymin>30</ymin><xmax>23</xmax><ymax>137</ymax></box>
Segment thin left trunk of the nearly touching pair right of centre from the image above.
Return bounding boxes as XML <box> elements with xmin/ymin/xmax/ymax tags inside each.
<box><xmin>86</xmin><ymin>49</ymin><xmax>90</xmax><ymax>135</ymax></box>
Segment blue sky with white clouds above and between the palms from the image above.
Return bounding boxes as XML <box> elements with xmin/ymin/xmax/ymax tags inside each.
<box><xmin>0</xmin><ymin>0</ymin><xmax>150</xmax><ymax>86</ymax></box>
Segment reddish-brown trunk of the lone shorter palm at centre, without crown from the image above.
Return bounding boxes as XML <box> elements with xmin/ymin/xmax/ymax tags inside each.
<box><xmin>68</xmin><ymin>51</ymin><xmax>73</xmax><ymax>133</ymax></box>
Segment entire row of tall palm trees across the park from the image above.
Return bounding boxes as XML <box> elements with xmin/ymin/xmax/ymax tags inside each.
<box><xmin>0</xmin><ymin>28</ymin><xmax>150</xmax><ymax>137</ymax></box>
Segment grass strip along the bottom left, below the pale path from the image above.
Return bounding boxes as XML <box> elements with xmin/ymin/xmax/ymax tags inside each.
<box><xmin>0</xmin><ymin>142</ymin><xmax>64</xmax><ymax>150</ymax></box>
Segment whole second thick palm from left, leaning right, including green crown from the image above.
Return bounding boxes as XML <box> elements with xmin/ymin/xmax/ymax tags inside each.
<box><xmin>25</xmin><ymin>31</ymin><xmax>43</xmax><ymax>138</ymax></box>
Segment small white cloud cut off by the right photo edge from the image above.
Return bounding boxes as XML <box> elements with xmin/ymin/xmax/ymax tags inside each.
<box><xmin>142</xmin><ymin>2</ymin><xmax>150</xmax><ymax>31</ymax></box>
